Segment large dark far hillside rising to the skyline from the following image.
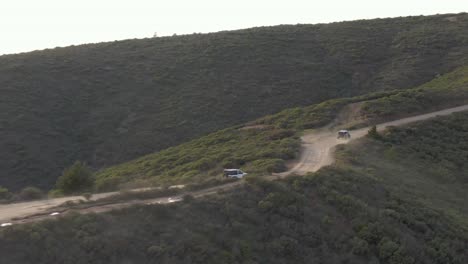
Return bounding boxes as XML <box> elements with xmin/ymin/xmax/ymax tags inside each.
<box><xmin>0</xmin><ymin>14</ymin><xmax>468</xmax><ymax>190</ymax></box>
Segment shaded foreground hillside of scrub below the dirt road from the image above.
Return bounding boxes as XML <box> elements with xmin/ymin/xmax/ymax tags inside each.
<box><xmin>0</xmin><ymin>112</ymin><xmax>468</xmax><ymax>264</ymax></box>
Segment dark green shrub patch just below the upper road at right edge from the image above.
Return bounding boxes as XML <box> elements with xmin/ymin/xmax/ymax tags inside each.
<box><xmin>383</xmin><ymin>113</ymin><xmax>468</xmax><ymax>184</ymax></box>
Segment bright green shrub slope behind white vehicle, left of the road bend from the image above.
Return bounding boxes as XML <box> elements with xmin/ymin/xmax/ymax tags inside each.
<box><xmin>95</xmin><ymin>127</ymin><xmax>299</xmax><ymax>190</ymax></box>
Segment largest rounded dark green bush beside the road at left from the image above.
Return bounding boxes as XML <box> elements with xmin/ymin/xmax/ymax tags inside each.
<box><xmin>56</xmin><ymin>161</ymin><xmax>93</xmax><ymax>194</ymax></box>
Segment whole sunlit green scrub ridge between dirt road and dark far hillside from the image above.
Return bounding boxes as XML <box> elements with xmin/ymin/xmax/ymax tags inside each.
<box><xmin>91</xmin><ymin>67</ymin><xmax>468</xmax><ymax>190</ymax></box>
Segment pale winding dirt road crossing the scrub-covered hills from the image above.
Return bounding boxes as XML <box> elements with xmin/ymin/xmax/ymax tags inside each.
<box><xmin>0</xmin><ymin>105</ymin><xmax>468</xmax><ymax>224</ymax></box>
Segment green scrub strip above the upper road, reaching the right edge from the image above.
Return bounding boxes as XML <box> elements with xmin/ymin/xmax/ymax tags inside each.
<box><xmin>254</xmin><ymin>67</ymin><xmax>468</xmax><ymax>130</ymax></box>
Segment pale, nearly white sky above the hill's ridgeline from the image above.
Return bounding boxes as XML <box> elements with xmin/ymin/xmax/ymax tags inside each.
<box><xmin>0</xmin><ymin>0</ymin><xmax>468</xmax><ymax>54</ymax></box>
